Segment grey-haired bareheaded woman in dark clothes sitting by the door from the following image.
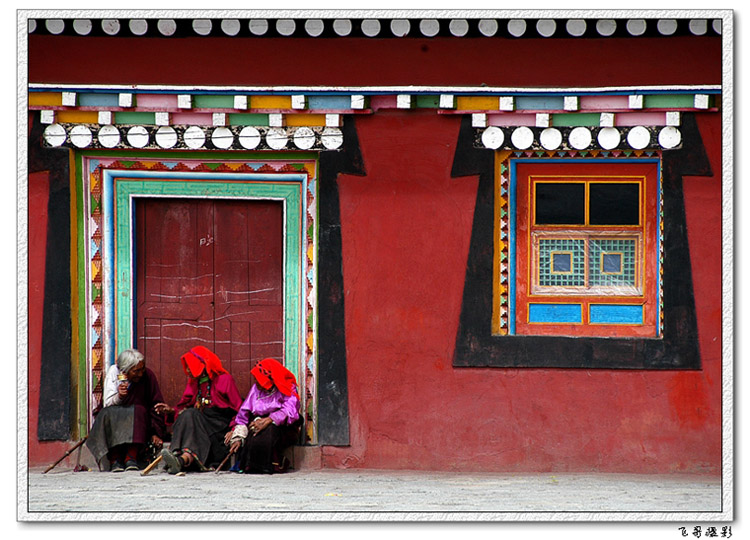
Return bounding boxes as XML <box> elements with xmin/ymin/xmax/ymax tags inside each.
<box><xmin>86</xmin><ymin>349</ymin><xmax>166</xmax><ymax>472</ymax></box>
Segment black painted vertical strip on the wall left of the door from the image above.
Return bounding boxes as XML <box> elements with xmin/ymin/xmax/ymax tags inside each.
<box><xmin>29</xmin><ymin>113</ymin><xmax>72</xmax><ymax>441</ymax></box>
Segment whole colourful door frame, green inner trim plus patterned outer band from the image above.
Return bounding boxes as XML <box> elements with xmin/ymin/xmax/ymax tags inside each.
<box><xmin>76</xmin><ymin>152</ymin><xmax>317</xmax><ymax>442</ymax></box>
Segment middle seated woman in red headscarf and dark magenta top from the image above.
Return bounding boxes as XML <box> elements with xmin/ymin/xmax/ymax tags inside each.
<box><xmin>155</xmin><ymin>346</ymin><xmax>242</xmax><ymax>474</ymax></box>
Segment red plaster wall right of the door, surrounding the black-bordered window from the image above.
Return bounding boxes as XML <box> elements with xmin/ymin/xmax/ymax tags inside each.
<box><xmin>323</xmin><ymin>111</ymin><xmax>721</xmax><ymax>474</ymax></box>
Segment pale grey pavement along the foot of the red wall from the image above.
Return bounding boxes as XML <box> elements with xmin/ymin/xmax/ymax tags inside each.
<box><xmin>18</xmin><ymin>466</ymin><xmax>726</xmax><ymax>521</ymax></box>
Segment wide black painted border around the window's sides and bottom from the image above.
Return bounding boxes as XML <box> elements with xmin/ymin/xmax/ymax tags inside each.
<box><xmin>452</xmin><ymin>114</ymin><xmax>711</xmax><ymax>369</ymax></box>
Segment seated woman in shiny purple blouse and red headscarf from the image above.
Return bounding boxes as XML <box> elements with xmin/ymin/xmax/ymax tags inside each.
<box><xmin>225</xmin><ymin>358</ymin><xmax>302</xmax><ymax>474</ymax></box>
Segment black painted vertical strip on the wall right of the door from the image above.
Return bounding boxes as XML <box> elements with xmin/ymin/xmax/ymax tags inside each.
<box><xmin>318</xmin><ymin>116</ymin><xmax>365</xmax><ymax>446</ymax></box>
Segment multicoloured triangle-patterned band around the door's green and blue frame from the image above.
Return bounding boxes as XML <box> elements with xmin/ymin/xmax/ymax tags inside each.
<box><xmin>84</xmin><ymin>154</ymin><xmax>317</xmax><ymax>442</ymax></box>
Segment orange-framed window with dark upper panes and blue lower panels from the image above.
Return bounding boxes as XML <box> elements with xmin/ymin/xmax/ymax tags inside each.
<box><xmin>508</xmin><ymin>160</ymin><xmax>660</xmax><ymax>337</ymax></box>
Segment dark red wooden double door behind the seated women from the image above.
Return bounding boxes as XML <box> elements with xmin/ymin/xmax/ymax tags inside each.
<box><xmin>136</xmin><ymin>198</ymin><xmax>284</xmax><ymax>404</ymax></box>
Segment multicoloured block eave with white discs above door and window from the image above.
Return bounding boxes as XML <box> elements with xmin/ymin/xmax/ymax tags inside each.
<box><xmin>28</xmin><ymin>84</ymin><xmax>721</xmax><ymax>151</ymax></box>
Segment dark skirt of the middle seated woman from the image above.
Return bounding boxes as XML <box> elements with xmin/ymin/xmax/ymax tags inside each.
<box><xmin>171</xmin><ymin>407</ymin><xmax>237</xmax><ymax>467</ymax></box>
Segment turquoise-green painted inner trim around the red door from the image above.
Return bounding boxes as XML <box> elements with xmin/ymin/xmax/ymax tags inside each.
<box><xmin>109</xmin><ymin>175</ymin><xmax>305</xmax><ymax>380</ymax></box>
